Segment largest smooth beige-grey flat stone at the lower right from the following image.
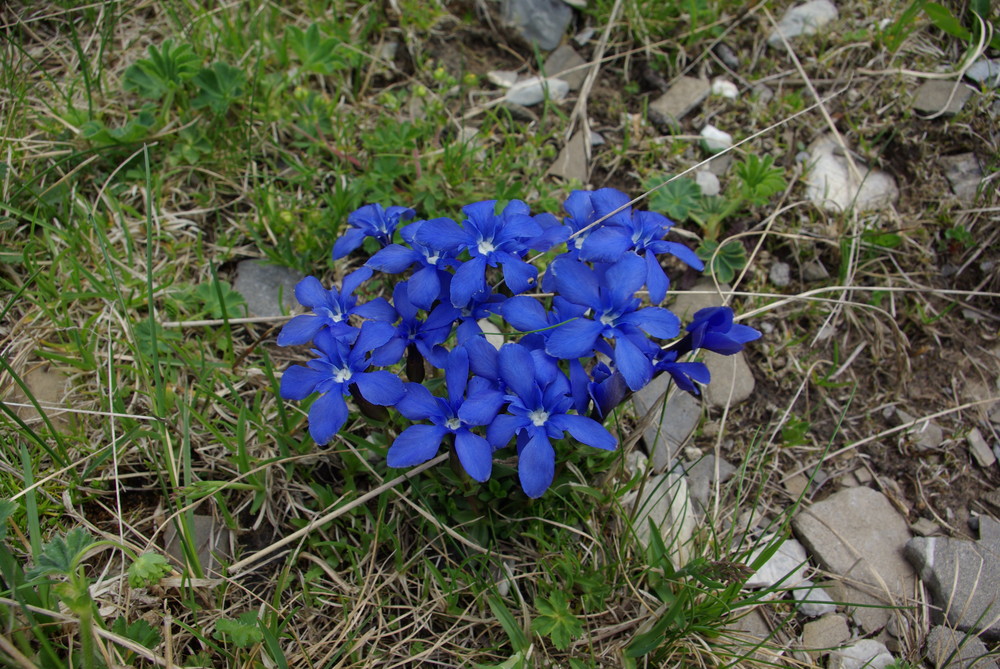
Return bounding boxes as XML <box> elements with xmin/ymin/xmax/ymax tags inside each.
<box><xmin>792</xmin><ymin>487</ymin><xmax>916</xmax><ymax>632</ymax></box>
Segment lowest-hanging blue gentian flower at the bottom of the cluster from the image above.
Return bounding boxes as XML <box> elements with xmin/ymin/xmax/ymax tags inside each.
<box><xmin>486</xmin><ymin>344</ymin><xmax>618</xmax><ymax>498</ymax></box>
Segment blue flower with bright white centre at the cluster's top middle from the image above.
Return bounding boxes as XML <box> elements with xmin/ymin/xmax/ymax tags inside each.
<box><xmin>416</xmin><ymin>200</ymin><xmax>543</xmax><ymax>309</ymax></box>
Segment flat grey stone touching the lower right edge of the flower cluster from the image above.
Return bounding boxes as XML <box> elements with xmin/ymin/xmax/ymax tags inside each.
<box><xmin>632</xmin><ymin>374</ymin><xmax>701</xmax><ymax>473</ymax></box>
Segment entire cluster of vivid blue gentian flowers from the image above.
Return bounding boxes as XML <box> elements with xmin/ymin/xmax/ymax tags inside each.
<box><xmin>278</xmin><ymin>188</ymin><xmax>760</xmax><ymax>497</ymax></box>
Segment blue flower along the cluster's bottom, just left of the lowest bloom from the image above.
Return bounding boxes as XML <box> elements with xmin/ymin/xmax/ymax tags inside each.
<box><xmin>386</xmin><ymin>346</ymin><xmax>504</xmax><ymax>482</ymax></box>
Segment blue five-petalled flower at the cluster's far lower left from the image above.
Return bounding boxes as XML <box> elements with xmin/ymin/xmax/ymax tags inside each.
<box><xmin>280</xmin><ymin>321</ymin><xmax>405</xmax><ymax>445</ymax></box>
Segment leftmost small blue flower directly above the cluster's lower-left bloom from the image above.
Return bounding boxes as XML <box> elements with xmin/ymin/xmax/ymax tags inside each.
<box><xmin>278</xmin><ymin>267</ymin><xmax>396</xmax><ymax>346</ymax></box>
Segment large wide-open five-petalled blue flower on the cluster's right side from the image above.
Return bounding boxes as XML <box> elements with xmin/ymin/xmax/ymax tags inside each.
<box><xmin>545</xmin><ymin>253</ymin><xmax>680</xmax><ymax>391</ymax></box>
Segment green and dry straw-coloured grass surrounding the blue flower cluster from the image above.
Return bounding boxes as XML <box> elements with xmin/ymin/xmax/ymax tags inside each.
<box><xmin>0</xmin><ymin>0</ymin><xmax>1000</xmax><ymax>667</ymax></box>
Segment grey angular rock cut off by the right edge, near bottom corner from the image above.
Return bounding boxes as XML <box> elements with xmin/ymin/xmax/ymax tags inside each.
<box><xmin>906</xmin><ymin>516</ymin><xmax>1000</xmax><ymax>641</ymax></box>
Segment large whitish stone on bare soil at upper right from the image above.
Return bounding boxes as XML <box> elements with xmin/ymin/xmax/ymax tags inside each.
<box><xmin>806</xmin><ymin>137</ymin><xmax>899</xmax><ymax>212</ymax></box>
